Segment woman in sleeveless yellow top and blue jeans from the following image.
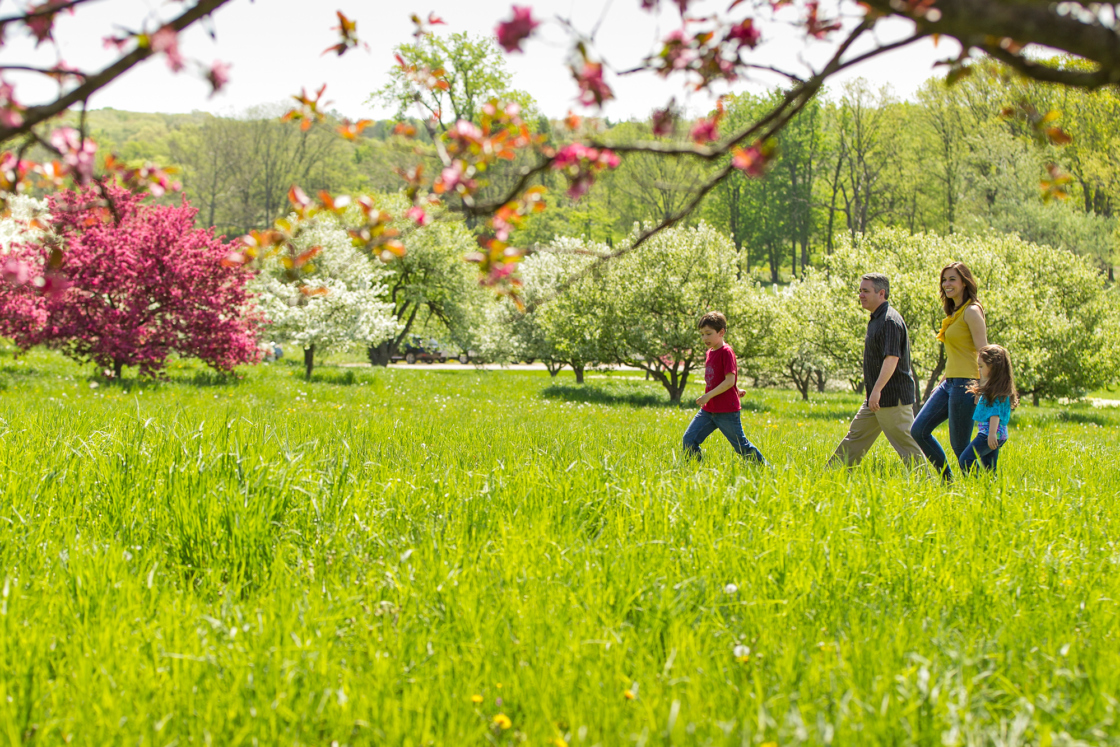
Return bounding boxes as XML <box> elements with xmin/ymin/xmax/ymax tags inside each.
<box><xmin>911</xmin><ymin>262</ymin><xmax>988</xmax><ymax>482</ymax></box>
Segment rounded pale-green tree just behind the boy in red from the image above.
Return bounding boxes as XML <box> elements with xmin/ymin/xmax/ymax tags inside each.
<box><xmin>601</xmin><ymin>223</ymin><xmax>738</xmax><ymax>402</ymax></box>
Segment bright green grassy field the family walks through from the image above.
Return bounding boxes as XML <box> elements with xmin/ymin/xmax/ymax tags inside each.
<box><xmin>0</xmin><ymin>353</ymin><xmax>1120</xmax><ymax>747</ymax></box>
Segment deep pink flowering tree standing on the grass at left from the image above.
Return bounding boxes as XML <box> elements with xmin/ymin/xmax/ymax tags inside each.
<box><xmin>0</xmin><ymin>187</ymin><xmax>262</xmax><ymax>379</ymax></box>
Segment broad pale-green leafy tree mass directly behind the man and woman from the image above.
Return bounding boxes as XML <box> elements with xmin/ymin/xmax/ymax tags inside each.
<box><xmin>785</xmin><ymin>230</ymin><xmax>1120</xmax><ymax>399</ymax></box>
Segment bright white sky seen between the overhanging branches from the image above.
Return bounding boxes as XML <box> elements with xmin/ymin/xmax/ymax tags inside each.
<box><xmin>0</xmin><ymin>0</ymin><xmax>960</xmax><ymax>120</ymax></box>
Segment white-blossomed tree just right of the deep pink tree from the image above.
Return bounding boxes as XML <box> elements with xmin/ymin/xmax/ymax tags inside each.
<box><xmin>252</xmin><ymin>216</ymin><xmax>399</xmax><ymax>379</ymax></box>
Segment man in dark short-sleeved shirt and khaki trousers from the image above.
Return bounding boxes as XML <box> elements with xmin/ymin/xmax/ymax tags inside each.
<box><xmin>829</xmin><ymin>272</ymin><xmax>928</xmax><ymax>474</ymax></box>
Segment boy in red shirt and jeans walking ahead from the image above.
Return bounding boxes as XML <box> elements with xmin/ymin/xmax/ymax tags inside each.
<box><xmin>684</xmin><ymin>311</ymin><xmax>767</xmax><ymax>464</ymax></box>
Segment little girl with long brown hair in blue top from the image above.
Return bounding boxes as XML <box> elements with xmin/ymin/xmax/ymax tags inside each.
<box><xmin>958</xmin><ymin>345</ymin><xmax>1019</xmax><ymax>473</ymax></box>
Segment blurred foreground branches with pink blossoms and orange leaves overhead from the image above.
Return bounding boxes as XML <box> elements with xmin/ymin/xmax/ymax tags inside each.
<box><xmin>0</xmin><ymin>0</ymin><xmax>1120</xmax><ymax>306</ymax></box>
